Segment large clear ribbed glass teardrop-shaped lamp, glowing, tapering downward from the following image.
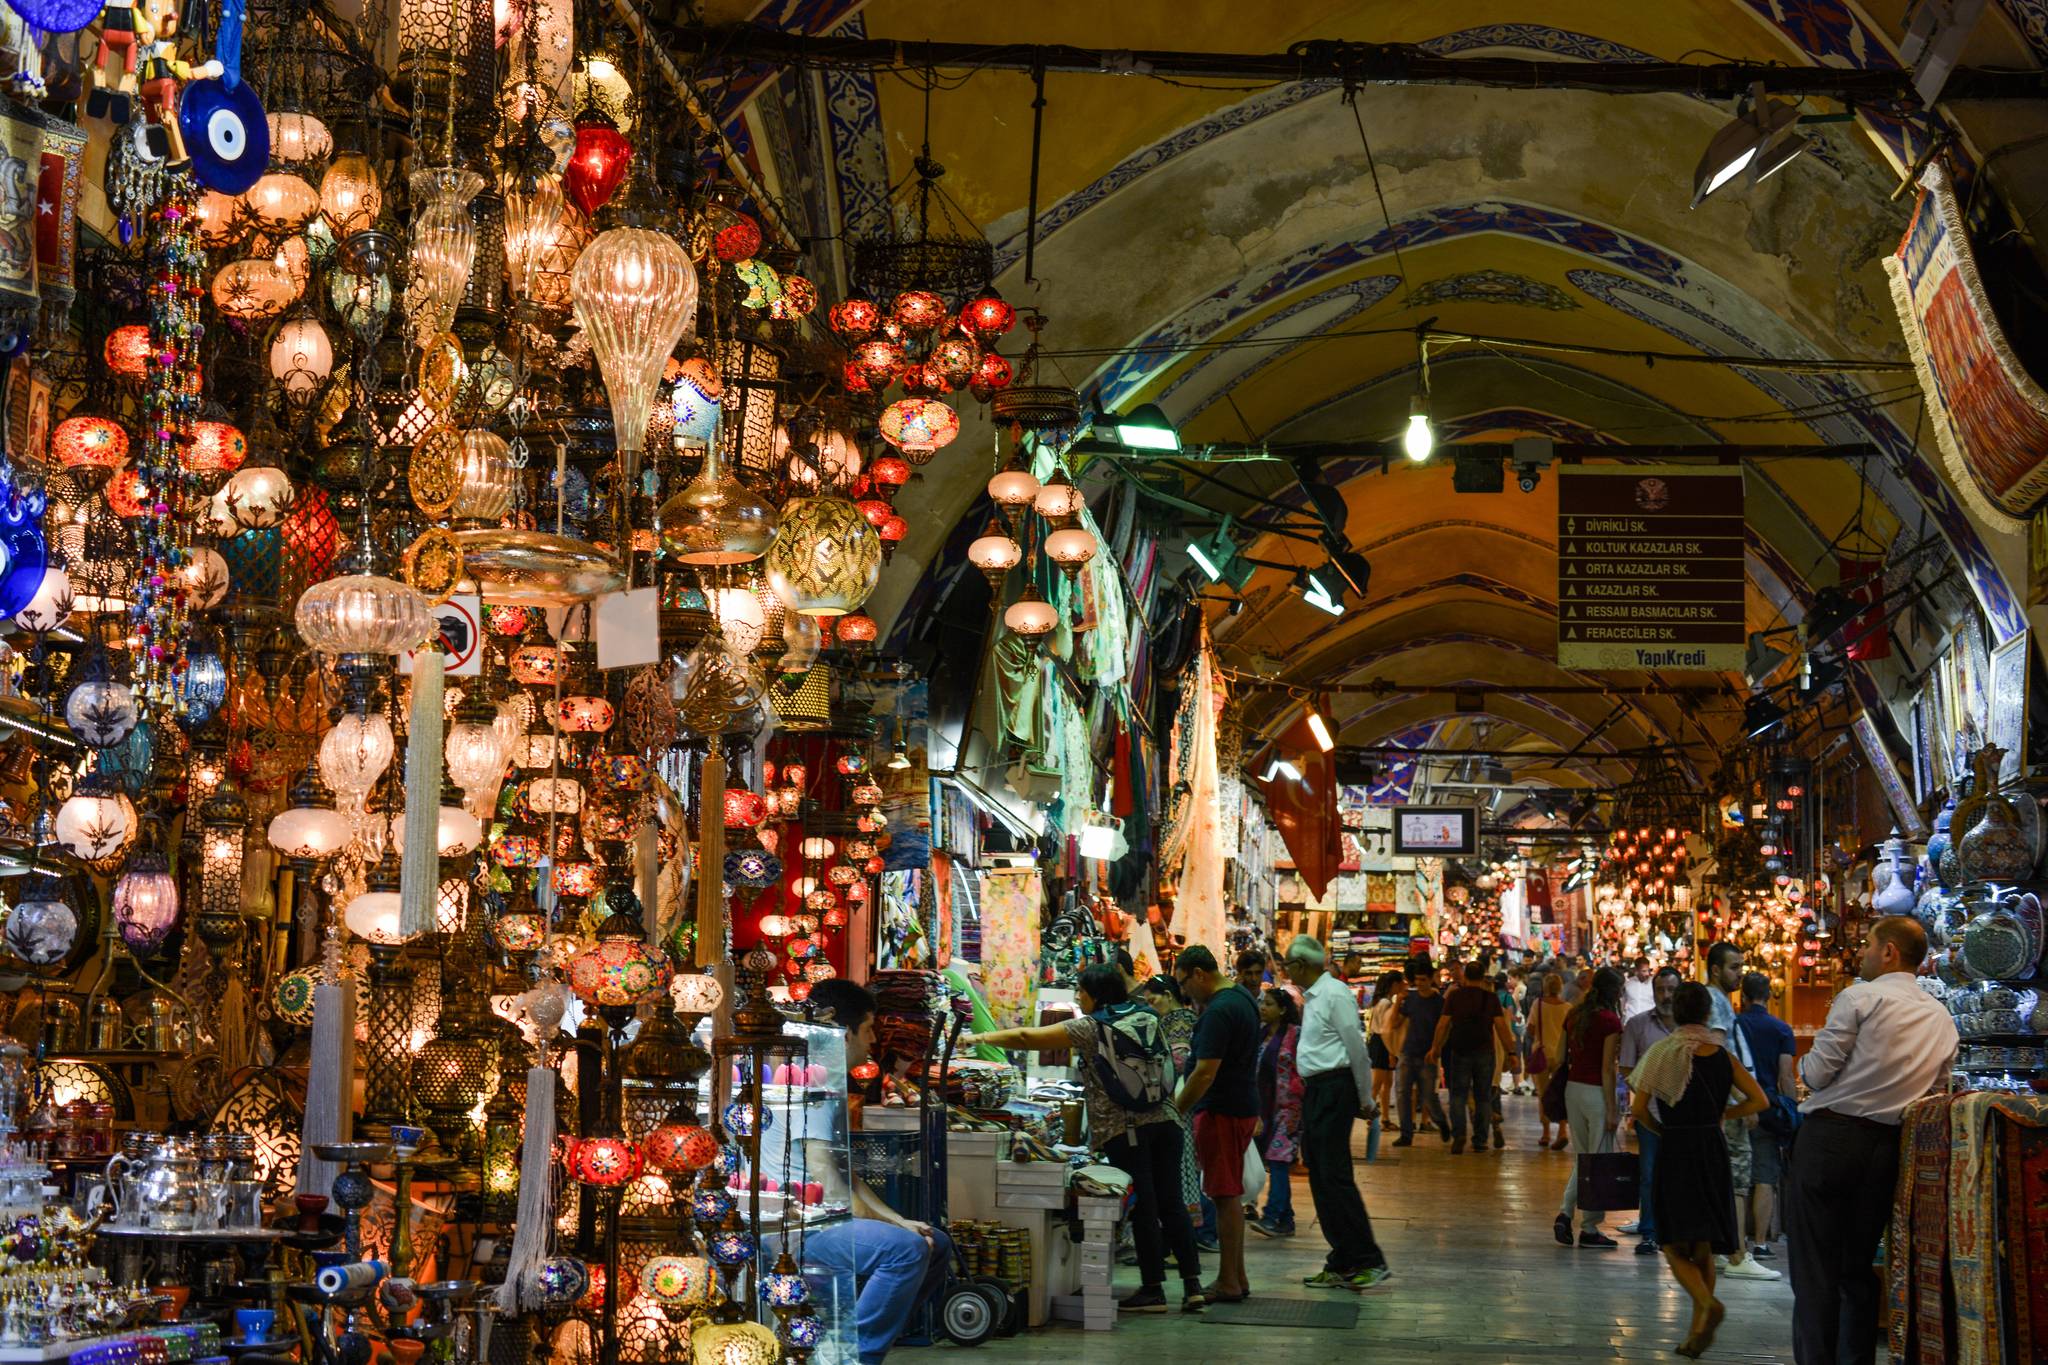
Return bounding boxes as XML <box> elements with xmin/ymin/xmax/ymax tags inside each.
<box><xmin>569</xmin><ymin>227</ymin><xmax>696</xmax><ymax>483</ymax></box>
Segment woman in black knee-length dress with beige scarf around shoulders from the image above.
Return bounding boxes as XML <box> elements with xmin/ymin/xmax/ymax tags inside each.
<box><xmin>1628</xmin><ymin>980</ymin><xmax>1765</xmax><ymax>1357</ymax></box>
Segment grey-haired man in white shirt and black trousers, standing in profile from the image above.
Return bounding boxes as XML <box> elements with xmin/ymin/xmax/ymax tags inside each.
<box><xmin>1282</xmin><ymin>935</ymin><xmax>1393</xmax><ymax>1289</ymax></box>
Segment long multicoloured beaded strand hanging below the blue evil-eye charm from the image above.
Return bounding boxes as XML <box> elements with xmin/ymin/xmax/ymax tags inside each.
<box><xmin>131</xmin><ymin>180</ymin><xmax>207</xmax><ymax>714</ymax></box>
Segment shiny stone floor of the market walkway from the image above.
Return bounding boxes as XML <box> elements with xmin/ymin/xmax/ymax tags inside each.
<box><xmin>974</xmin><ymin>1099</ymin><xmax>1792</xmax><ymax>1365</ymax></box>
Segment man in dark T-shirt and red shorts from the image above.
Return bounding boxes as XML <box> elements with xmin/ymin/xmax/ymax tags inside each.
<box><xmin>1174</xmin><ymin>943</ymin><xmax>1260</xmax><ymax>1304</ymax></box>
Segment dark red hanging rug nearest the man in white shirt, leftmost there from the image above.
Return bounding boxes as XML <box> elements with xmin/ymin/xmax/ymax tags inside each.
<box><xmin>1884</xmin><ymin>1095</ymin><xmax>1954</xmax><ymax>1365</ymax></box>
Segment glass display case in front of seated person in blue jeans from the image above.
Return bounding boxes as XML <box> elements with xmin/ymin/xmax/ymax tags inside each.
<box><xmin>717</xmin><ymin>1021</ymin><xmax>860</xmax><ymax>1365</ymax></box>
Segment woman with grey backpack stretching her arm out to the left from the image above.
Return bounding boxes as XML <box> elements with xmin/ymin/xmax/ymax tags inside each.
<box><xmin>961</xmin><ymin>966</ymin><xmax>1206</xmax><ymax>1314</ymax></box>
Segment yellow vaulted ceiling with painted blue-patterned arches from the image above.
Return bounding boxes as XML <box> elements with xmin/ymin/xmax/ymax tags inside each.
<box><xmin>707</xmin><ymin>0</ymin><xmax>2048</xmax><ymax>784</ymax></box>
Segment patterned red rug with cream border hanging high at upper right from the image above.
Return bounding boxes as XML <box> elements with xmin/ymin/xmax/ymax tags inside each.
<box><xmin>1884</xmin><ymin>166</ymin><xmax>2048</xmax><ymax>532</ymax></box>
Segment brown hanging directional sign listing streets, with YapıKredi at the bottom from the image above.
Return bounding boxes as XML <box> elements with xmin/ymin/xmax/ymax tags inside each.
<box><xmin>1556</xmin><ymin>465</ymin><xmax>1745</xmax><ymax>671</ymax></box>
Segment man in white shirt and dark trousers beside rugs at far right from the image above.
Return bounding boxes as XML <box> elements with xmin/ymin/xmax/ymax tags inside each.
<box><xmin>1786</xmin><ymin>915</ymin><xmax>1956</xmax><ymax>1365</ymax></box>
